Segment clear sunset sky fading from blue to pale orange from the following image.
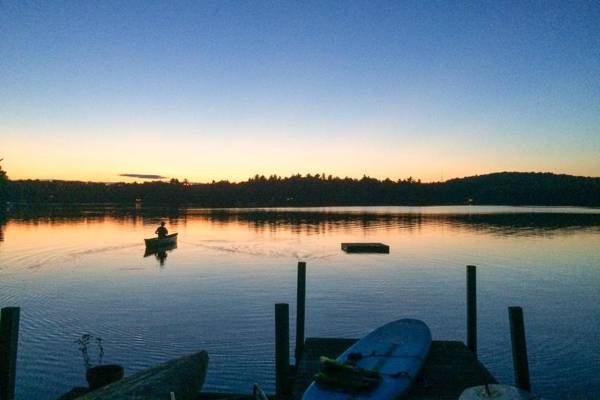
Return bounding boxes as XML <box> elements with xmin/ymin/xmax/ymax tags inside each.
<box><xmin>0</xmin><ymin>0</ymin><xmax>600</xmax><ymax>182</ymax></box>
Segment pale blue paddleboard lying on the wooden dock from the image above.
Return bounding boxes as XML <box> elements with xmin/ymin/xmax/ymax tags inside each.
<box><xmin>302</xmin><ymin>319</ymin><xmax>431</xmax><ymax>400</ymax></box>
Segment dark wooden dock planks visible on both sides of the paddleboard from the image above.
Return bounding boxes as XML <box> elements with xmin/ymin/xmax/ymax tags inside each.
<box><xmin>292</xmin><ymin>338</ymin><xmax>497</xmax><ymax>400</ymax></box>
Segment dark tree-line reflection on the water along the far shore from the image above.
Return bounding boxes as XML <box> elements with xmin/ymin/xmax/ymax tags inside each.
<box><xmin>0</xmin><ymin>206</ymin><xmax>600</xmax><ymax>235</ymax></box>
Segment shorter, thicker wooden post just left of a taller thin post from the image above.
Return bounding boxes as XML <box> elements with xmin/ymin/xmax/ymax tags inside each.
<box><xmin>275</xmin><ymin>303</ymin><xmax>290</xmax><ymax>399</ymax></box>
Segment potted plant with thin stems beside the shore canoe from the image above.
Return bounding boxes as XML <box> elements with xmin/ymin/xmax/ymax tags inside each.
<box><xmin>75</xmin><ymin>333</ymin><xmax>124</xmax><ymax>390</ymax></box>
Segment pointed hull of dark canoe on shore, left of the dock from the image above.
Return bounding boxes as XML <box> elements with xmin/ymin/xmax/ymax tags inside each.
<box><xmin>78</xmin><ymin>351</ymin><xmax>208</xmax><ymax>400</ymax></box>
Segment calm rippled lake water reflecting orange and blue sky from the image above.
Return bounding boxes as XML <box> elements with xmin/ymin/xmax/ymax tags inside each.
<box><xmin>0</xmin><ymin>207</ymin><xmax>600</xmax><ymax>399</ymax></box>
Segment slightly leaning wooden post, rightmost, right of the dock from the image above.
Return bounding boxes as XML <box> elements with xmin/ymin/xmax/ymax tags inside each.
<box><xmin>508</xmin><ymin>307</ymin><xmax>531</xmax><ymax>391</ymax></box>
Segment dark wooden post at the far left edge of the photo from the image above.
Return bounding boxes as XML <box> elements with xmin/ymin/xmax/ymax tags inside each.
<box><xmin>0</xmin><ymin>307</ymin><xmax>21</xmax><ymax>400</ymax></box>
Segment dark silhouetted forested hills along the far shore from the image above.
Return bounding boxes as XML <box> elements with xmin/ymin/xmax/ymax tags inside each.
<box><xmin>0</xmin><ymin>172</ymin><xmax>600</xmax><ymax>207</ymax></box>
